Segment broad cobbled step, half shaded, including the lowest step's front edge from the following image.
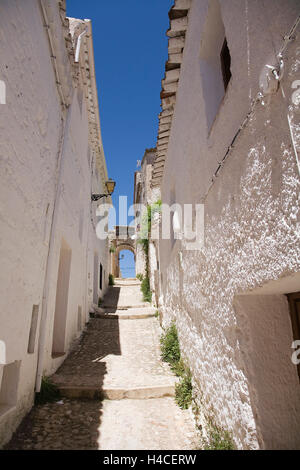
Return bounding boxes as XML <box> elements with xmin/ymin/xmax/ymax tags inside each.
<box><xmin>52</xmin><ymin>318</ymin><xmax>177</xmax><ymax>399</ymax></box>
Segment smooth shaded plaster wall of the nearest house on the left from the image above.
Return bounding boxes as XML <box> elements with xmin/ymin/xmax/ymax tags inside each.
<box><xmin>0</xmin><ymin>1</ymin><xmax>61</xmax><ymax>443</ymax></box>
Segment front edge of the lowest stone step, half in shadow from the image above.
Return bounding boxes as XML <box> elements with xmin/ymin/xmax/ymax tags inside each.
<box><xmin>58</xmin><ymin>384</ymin><xmax>175</xmax><ymax>400</ymax></box>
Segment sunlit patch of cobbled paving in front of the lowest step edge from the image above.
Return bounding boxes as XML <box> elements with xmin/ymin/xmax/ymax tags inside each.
<box><xmin>98</xmin><ymin>397</ymin><xmax>200</xmax><ymax>451</ymax></box>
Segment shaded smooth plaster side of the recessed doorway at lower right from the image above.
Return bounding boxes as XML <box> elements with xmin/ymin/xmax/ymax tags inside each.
<box><xmin>234</xmin><ymin>295</ymin><xmax>300</xmax><ymax>449</ymax></box>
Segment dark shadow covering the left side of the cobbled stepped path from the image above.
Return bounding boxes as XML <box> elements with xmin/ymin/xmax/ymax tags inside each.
<box><xmin>4</xmin><ymin>287</ymin><xmax>121</xmax><ymax>450</ymax></box>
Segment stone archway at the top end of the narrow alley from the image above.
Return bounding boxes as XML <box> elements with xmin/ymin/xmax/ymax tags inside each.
<box><xmin>109</xmin><ymin>226</ymin><xmax>136</xmax><ymax>278</ymax></box>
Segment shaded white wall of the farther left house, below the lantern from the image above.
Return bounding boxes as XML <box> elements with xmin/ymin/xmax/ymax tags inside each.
<box><xmin>45</xmin><ymin>93</ymin><xmax>108</xmax><ymax>374</ymax></box>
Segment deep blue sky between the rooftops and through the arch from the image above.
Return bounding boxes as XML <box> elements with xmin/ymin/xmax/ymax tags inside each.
<box><xmin>67</xmin><ymin>0</ymin><xmax>173</xmax><ymax>276</ymax></box>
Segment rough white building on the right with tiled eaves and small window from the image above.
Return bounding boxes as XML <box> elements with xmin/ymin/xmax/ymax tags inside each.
<box><xmin>153</xmin><ymin>0</ymin><xmax>300</xmax><ymax>449</ymax></box>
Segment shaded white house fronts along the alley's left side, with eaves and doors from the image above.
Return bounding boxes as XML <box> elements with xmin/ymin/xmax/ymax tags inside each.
<box><xmin>0</xmin><ymin>0</ymin><xmax>109</xmax><ymax>445</ymax></box>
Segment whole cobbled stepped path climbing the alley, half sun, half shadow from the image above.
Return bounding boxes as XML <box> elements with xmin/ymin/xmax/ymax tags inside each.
<box><xmin>6</xmin><ymin>280</ymin><xmax>197</xmax><ymax>450</ymax></box>
